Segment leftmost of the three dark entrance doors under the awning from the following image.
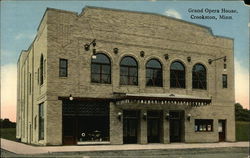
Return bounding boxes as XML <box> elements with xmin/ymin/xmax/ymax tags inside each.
<box><xmin>123</xmin><ymin>111</ymin><xmax>139</xmax><ymax>144</ymax></box>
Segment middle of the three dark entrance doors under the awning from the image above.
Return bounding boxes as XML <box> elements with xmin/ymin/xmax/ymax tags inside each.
<box><xmin>147</xmin><ymin>111</ymin><xmax>162</xmax><ymax>143</ymax></box>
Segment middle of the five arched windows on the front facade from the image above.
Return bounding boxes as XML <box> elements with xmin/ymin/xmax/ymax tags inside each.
<box><xmin>146</xmin><ymin>59</ymin><xmax>162</xmax><ymax>87</ymax></box>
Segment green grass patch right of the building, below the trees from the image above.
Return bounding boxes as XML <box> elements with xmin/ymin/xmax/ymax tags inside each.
<box><xmin>236</xmin><ymin>121</ymin><xmax>250</xmax><ymax>141</ymax></box>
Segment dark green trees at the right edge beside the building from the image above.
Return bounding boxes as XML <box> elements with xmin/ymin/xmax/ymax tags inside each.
<box><xmin>234</xmin><ymin>103</ymin><xmax>250</xmax><ymax>121</ymax></box>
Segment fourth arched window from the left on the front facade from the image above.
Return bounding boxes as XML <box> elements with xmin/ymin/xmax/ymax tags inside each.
<box><xmin>170</xmin><ymin>61</ymin><xmax>185</xmax><ymax>88</ymax></box>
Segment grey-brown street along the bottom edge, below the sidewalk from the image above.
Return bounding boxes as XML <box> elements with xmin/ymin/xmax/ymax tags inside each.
<box><xmin>1</xmin><ymin>147</ymin><xmax>249</xmax><ymax>158</ymax></box>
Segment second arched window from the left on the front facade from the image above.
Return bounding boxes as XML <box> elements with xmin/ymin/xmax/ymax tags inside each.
<box><xmin>120</xmin><ymin>56</ymin><xmax>138</xmax><ymax>85</ymax></box>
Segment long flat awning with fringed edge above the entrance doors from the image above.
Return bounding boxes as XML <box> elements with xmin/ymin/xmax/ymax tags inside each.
<box><xmin>114</xmin><ymin>93</ymin><xmax>212</xmax><ymax>106</ymax></box>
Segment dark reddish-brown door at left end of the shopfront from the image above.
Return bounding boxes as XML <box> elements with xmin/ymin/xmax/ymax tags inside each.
<box><xmin>63</xmin><ymin>116</ymin><xmax>76</xmax><ymax>145</ymax></box>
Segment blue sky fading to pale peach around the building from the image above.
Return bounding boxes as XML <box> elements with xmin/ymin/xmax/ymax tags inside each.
<box><xmin>0</xmin><ymin>0</ymin><xmax>250</xmax><ymax>121</ymax></box>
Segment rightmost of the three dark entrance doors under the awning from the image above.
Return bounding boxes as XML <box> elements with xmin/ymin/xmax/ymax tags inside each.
<box><xmin>169</xmin><ymin>111</ymin><xmax>183</xmax><ymax>142</ymax></box>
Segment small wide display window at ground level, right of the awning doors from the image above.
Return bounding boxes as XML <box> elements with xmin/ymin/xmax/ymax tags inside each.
<box><xmin>195</xmin><ymin>119</ymin><xmax>213</xmax><ymax>132</ymax></box>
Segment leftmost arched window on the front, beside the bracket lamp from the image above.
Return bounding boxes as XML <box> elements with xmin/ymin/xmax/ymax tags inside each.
<box><xmin>91</xmin><ymin>53</ymin><xmax>111</xmax><ymax>83</ymax></box>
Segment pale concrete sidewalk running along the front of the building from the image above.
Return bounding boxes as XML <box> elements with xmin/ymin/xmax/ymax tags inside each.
<box><xmin>1</xmin><ymin>138</ymin><xmax>249</xmax><ymax>154</ymax></box>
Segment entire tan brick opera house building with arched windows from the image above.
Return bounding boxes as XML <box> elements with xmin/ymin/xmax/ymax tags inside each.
<box><xmin>16</xmin><ymin>7</ymin><xmax>235</xmax><ymax>145</ymax></box>
